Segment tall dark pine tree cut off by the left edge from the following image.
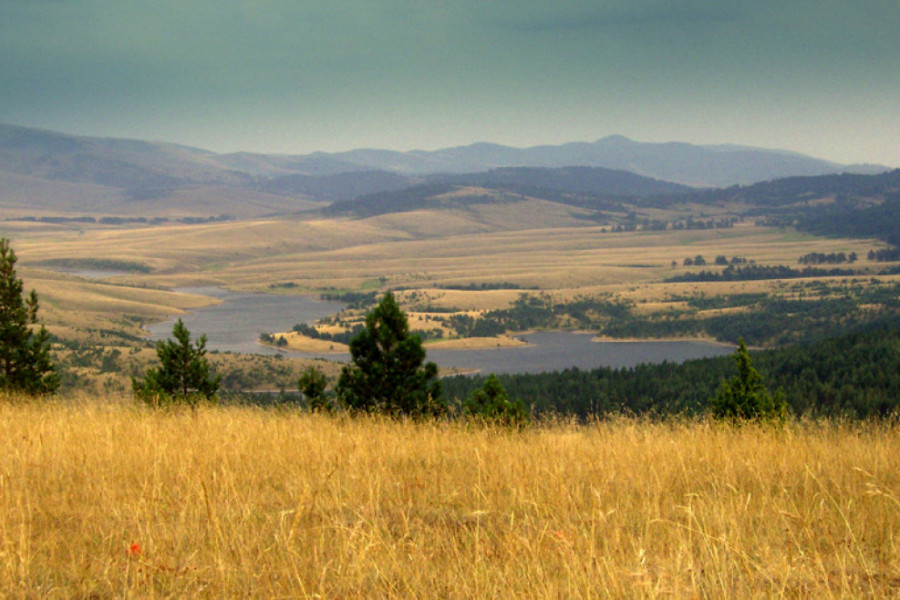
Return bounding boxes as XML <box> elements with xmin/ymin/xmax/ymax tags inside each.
<box><xmin>0</xmin><ymin>238</ymin><xmax>59</xmax><ymax>395</ymax></box>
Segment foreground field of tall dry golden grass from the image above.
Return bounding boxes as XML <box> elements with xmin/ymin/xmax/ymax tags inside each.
<box><xmin>0</xmin><ymin>400</ymin><xmax>900</xmax><ymax>598</ymax></box>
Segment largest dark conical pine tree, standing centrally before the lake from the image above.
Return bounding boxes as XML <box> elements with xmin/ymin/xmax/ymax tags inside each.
<box><xmin>337</xmin><ymin>292</ymin><xmax>445</xmax><ymax>416</ymax></box>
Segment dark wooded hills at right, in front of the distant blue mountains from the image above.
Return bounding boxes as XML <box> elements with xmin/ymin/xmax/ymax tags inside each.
<box><xmin>314</xmin><ymin>167</ymin><xmax>900</xmax><ymax>245</ymax></box>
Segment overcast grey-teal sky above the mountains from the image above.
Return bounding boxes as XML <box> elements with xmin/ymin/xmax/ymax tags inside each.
<box><xmin>0</xmin><ymin>0</ymin><xmax>900</xmax><ymax>166</ymax></box>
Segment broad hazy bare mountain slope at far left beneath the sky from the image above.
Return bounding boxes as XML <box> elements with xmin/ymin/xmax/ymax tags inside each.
<box><xmin>0</xmin><ymin>125</ymin><xmax>316</xmax><ymax>218</ymax></box>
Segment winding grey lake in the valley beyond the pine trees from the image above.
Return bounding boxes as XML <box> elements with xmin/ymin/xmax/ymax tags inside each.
<box><xmin>147</xmin><ymin>287</ymin><xmax>734</xmax><ymax>373</ymax></box>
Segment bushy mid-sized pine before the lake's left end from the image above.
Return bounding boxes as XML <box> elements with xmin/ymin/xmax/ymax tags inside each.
<box><xmin>131</xmin><ymin>319</ymin><xmax>221</xmax><ymax>406</ymax></box>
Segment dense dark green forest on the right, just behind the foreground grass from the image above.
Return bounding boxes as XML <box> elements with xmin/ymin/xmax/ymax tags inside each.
<box><xmin>443</xmin><ymin>317</ymin><xmax>900</xmax><ymax>418</ymax></box>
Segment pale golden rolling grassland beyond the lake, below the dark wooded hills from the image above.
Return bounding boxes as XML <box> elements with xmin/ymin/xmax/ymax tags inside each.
<box><xmin>13</xmin><ymin>212</ymin><xmax>879</xmax><ymax>291</ymax></box>
